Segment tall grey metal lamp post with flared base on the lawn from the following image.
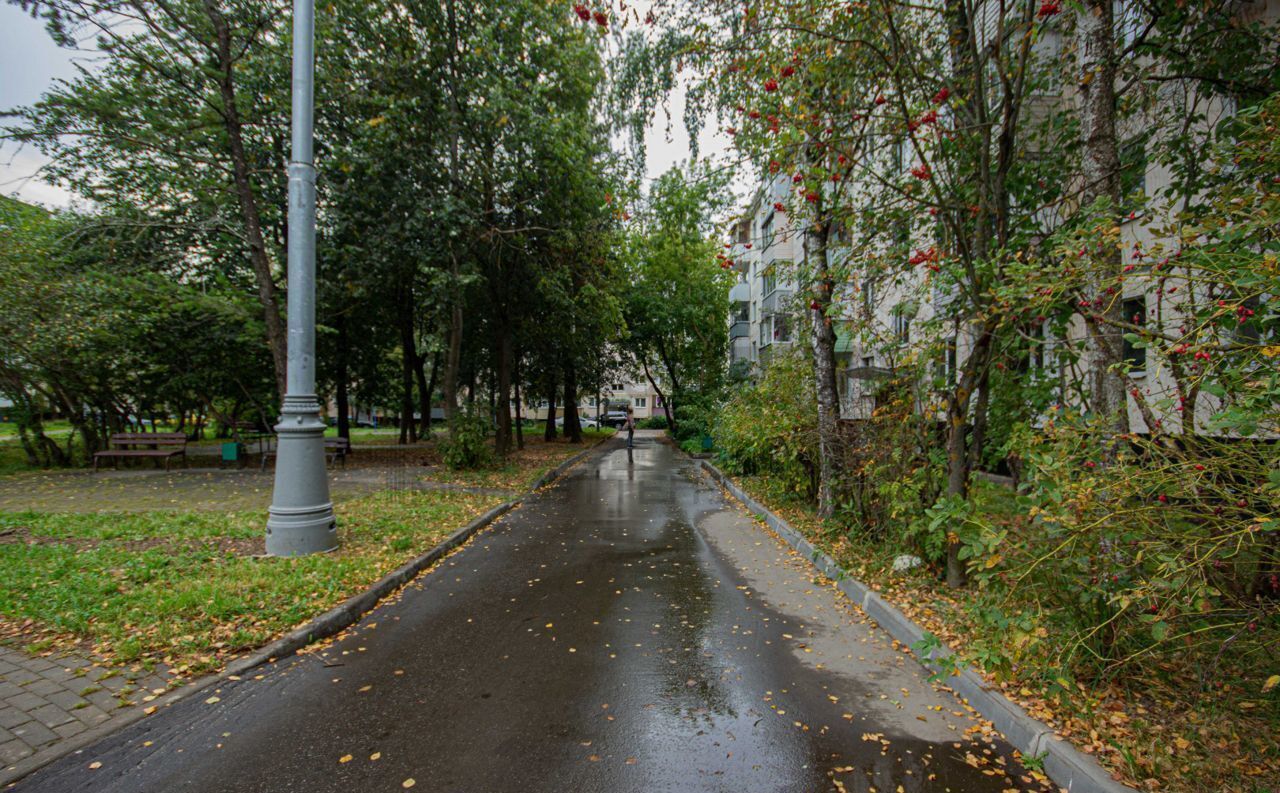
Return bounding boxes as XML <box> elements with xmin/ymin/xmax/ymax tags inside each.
<box><xmin>266</xmin><ymin>0</ymin><xmax>338</xmax><ymax>556</ymax></box>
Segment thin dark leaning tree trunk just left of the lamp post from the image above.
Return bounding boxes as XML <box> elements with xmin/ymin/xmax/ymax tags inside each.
<box><xmin>204</xmin><ymin>0</ymin><xmax>288</xmax><ymax>399</ymax></box>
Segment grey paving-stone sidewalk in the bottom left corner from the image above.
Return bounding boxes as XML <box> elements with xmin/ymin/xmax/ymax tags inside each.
<box><xmin>0</xmin><ymin>646</ymin><xmax>169</xmax><ymax>769</ymax></box>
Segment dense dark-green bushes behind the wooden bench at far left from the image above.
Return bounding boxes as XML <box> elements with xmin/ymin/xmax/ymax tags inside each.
<box><xmin>0</xmin><ymin>198</ymin><xmax>271</xmax><ymax>466</ymax></box>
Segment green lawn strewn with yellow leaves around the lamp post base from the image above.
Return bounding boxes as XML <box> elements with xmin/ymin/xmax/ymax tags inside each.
<box><xmin>0</xmin><ymin>491</ymin><xmax>503</xmax><ymax>673</ymax></box>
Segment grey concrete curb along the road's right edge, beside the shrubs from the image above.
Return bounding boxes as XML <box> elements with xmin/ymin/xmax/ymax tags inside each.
<box><xmin>698</xmin><ymin>460</ymin><xmax>1134</xmax><ymax>793</ymax></box>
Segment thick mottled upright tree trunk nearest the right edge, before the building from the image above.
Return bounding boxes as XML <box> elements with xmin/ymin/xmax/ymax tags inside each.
<box><xmin>1075</xmin><ymin>0</ymin><xmax>1129</xmax><ymax>435</ymax></box>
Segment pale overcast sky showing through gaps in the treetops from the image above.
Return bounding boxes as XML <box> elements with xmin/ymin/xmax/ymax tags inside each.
<box><xmin>0</xmin><ymin>0</ymin><xmax>730</xmax><ymax>219</ymax></box>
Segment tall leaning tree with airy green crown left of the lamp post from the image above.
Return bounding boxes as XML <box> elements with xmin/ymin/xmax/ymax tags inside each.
<box><xmin>3</xmin><ymin>0</ymin><xmax>289</xmax><ymax>394</ymax></box>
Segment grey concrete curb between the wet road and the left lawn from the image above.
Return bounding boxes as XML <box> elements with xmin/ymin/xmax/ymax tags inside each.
<box><xmin>0</xmin><ymin>441</ymin><xmax>608</xmax><ymax>787</ymax></box>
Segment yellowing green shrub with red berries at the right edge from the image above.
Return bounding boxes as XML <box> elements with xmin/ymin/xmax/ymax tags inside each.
<box><xmin>962</xmin><ymin>97</ymin><xmax>1280</xmax><ymax>669</ymax></box>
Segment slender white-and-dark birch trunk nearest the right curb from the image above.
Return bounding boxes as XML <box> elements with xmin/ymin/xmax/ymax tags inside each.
<box><xmin>804</xmin><ymin>206</ymin><xmax>840</xmax><ymax>518</ymax></box>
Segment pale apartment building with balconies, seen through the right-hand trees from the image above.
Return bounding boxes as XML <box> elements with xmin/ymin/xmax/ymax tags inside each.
<box><xmin>730</xmin><ymin>0</ymin><xmax>1280</xmax><ymax>432</ymax></box>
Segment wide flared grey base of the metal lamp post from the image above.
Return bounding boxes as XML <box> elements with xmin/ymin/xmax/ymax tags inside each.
<box><xmin>266</xmin><ymin>395</ymin><xmax>338</xmax><ymax>556</ymax></box>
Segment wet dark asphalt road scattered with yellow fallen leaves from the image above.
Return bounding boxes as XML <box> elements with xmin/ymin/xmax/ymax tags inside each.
<box><xmin>17</xmin><ymin>435</ymin><xmax>1041</xmax><ymax>793</ymax></box>
